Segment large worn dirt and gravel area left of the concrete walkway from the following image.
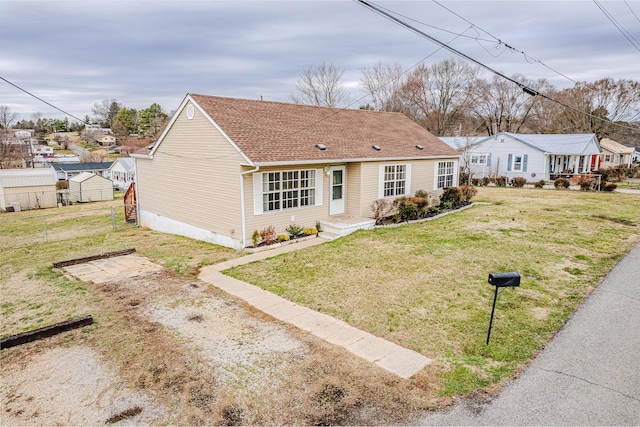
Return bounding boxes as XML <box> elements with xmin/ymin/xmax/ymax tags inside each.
<box><xmin>1</xmin><ymin>260</ymin><xmax>442</xmax><ymax>425</ymax></box>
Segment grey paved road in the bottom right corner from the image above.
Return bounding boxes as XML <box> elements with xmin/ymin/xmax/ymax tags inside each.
<box><xmin>421</xmin><ymin>245</ymin><xmax>640</xmax><ymax>425</ymax></box>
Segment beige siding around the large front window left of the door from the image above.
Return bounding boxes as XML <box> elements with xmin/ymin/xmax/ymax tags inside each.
<box><xmin>244</xmin><ymin>165</ymin><xmax>332</xmax><ymax>241</ymax></box>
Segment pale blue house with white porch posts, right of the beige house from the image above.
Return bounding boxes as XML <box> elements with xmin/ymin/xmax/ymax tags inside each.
<box><xmin>464</xmin><ymin>132</ymin><xmax>601</xmax><ymax>182</ymax></box>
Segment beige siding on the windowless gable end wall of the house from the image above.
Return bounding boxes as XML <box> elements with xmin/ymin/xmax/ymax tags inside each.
<box><xmin>136</xmin><ymin>103</ymin><xmax>246</xmax><ymax>239</ymax></box>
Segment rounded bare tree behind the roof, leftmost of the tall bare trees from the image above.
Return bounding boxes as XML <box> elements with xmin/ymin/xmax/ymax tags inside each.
<box><xmin>291</xmin><ymin>62</ymin><xmax>349</xmax><ymax>107</ymax></box>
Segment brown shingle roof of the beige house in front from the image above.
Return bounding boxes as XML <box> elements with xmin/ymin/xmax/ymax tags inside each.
<box><xmin>189</xmin><ymin>94</ymin><xmax>458</xmax><ymax>163</ymax></box>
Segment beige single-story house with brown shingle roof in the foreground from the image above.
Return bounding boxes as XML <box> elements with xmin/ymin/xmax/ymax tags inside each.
<box><xmin>132</xmin><ymin>94</ymin><xmax>459</xmax><ymax>248</ymax></box>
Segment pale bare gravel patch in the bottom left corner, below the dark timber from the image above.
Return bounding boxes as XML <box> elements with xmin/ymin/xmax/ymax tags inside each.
<box><xmin>2</xmin><ymin>347</ymin><xmax>168</xmax><ymax>425</ymax></box>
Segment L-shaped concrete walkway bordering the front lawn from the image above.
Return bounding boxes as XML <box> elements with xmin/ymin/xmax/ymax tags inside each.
<box><xmin>199</xmin><ymin>238</ymin><xmax>431</xmax><ymax>378</ymax></box>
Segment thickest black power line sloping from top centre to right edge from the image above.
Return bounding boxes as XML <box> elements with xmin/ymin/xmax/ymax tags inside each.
<box><xmin>354</xmin><ymin>0</ymin><xmax>638</xmax><ymax>130</ymax></box>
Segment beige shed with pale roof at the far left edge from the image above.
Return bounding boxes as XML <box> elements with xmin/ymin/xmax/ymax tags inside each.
<box><xmin>0</xmin><ymin>167</ymin><xmax>58</xmax><ymax>211</ymax></box>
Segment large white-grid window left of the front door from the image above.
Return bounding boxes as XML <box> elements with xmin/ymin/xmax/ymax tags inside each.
<box><xmin>262</xmin><ymin>170</ymin><xmax>316</xmax><ymax>212</ymax></box>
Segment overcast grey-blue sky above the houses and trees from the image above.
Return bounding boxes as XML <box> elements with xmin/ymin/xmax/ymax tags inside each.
<box><xmin>0</xmin><ymin>0</ymin><xmax>640</xmax><ymax>121</ymax></box>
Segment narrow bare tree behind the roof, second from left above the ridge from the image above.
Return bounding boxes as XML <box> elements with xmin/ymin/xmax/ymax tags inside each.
<box><xmin>360</xmin><ymin>62</ymin><xmax>405</xmax><ymax>112</ymax></box>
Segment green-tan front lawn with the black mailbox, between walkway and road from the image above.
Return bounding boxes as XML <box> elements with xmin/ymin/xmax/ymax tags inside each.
<box><xmin>225</xmin><ymin>187</ymin><xmax>640</xmax><ymax>395</ymax></box>
